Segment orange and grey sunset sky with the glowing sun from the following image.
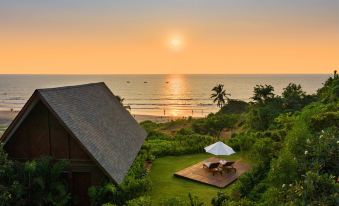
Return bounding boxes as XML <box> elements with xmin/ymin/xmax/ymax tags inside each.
<box><xmin>0</xmin><ymin>0</ymin><xmax>339</xmax><ymax>74</ymax></box>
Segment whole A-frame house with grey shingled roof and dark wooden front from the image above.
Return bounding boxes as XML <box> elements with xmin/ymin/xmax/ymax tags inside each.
<box><xmin>1</xmin><ymin>83</ymin><xmax>146</xmax><ymax>205</ymax></box>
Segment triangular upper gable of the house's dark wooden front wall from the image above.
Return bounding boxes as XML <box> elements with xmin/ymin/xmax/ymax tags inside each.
<box><xmin>5</xmin><ymin>101</ymin><xmax>91</xmax><ymax>161</ymax></box>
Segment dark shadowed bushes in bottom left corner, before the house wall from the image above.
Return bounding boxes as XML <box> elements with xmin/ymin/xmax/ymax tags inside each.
<box><xmin>0</xmin><ymin>150</ymin><xmax>71</xmax><ymax>205</ymax></box>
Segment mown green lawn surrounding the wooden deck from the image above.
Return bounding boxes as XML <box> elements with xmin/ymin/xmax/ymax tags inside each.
<box><xmin>150</xmin><ymin>153</ymin><xmax>248</xmax><ymax>205</ymax></box>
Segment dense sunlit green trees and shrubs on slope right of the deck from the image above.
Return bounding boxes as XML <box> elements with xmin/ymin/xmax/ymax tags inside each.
<box><xmin>212</xmin><ymin>73</ymin><xmax>339</xmax><ymax>206</ymax></box>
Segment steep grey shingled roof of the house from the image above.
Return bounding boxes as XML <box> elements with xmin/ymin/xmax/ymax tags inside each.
<box><xmin>4</xmin><ymin>83</ymin><xmax>146</xmax><ymax>183</ymax></box>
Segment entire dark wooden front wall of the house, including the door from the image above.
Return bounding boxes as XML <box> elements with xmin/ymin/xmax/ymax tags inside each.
<box><xmin>5</xmin><ymin>101</ymin><xmax>105</xmax><ymax>205</ymax></box>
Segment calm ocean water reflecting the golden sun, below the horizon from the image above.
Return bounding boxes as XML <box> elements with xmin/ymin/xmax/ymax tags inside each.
<box><xmin>0</xmin><ymin>74</ymin><xmax>330</xmax><ymax>117</ymax></box>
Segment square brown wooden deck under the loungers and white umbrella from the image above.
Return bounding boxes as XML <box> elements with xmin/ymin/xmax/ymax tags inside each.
<box><xmin>174</xmin><ymin>157</ymin><xmax>251</xmax><ymax>188</ymax></box>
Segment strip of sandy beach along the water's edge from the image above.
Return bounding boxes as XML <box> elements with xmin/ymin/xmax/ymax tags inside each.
<box><xmin>0</xmin><ymin>111</ymin><xmax>197</xmax><ymax>127</ymax></box>
